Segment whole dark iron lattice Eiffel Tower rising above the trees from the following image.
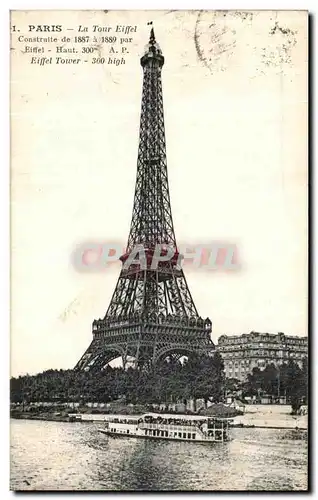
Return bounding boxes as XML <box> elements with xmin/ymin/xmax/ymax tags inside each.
<box><xmin>75</xmin><ymin>28</ymin><xmax>215</xmax><ymax>370</ymax></box>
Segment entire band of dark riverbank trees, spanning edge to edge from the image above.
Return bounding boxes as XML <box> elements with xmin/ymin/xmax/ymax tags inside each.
<box><xmin>11</xmin><ymin>353</ymin><xmax>308</xmax><ymax>411</ymax></box>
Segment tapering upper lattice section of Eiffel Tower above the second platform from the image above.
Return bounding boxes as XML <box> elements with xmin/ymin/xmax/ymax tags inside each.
<box><xmin>126</xmin><ymin>28</ymin><xmax>177</xmax><ymax>254</ymax></box>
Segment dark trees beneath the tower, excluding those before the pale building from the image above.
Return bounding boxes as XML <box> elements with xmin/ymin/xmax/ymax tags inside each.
<box><xmin>11</xmin><ymin>353</ymin><xmax>224</xmax><ymax>403</ymax></box>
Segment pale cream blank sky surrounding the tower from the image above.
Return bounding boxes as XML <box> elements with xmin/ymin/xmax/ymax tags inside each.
<box><xmin>11</xmin><ymin>11</ymin><xmax>308</xmax><ymax>376</ymax></box>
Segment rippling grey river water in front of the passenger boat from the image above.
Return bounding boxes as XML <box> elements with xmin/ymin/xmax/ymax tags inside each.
<box><xmin>10</xmin><ymin>420</ymin><xmax>307</xmax><ymax>491</ymax></box>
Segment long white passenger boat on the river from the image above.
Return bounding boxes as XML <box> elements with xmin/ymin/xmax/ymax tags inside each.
<box><xmin>99</xmin><ymin>413</ymin><xmax>230</xmax><ymax>443</ymax></box>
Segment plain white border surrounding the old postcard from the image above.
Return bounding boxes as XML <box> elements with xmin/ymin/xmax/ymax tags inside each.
<box><xmin>0</xmin><ymin>0</ymin><xmax>318</xmax><ymax>498</ymax></box>
